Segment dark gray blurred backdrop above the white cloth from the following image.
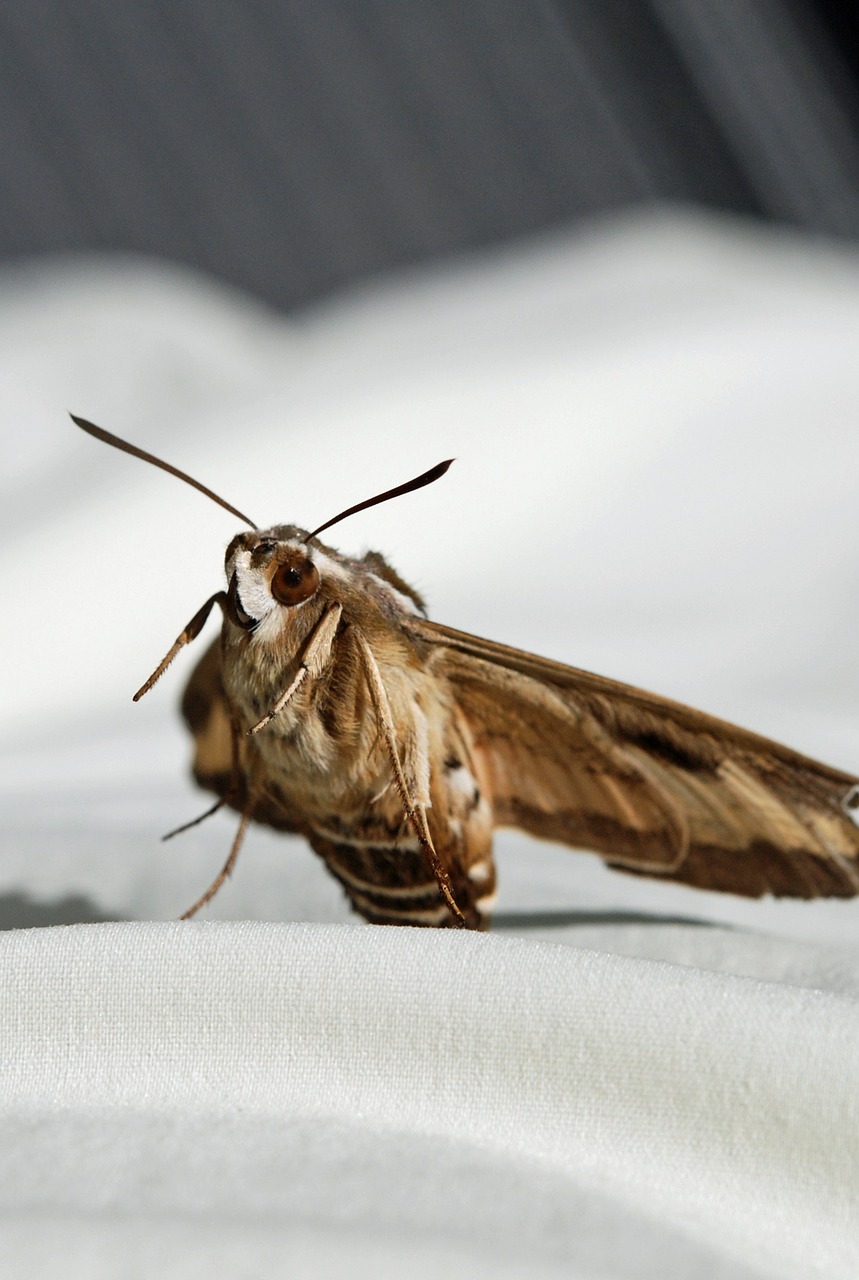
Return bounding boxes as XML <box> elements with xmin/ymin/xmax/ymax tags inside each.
<box><xmin>0</xmin><ymin>0</ymin><xmax>859</xmax><ymax>308</ymax></box>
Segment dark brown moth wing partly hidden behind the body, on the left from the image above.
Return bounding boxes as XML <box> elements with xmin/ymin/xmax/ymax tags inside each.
<box><xmin>182</xmin><ymin>640</ymin><xmax>302</xmax><ymax>831</ymax></box>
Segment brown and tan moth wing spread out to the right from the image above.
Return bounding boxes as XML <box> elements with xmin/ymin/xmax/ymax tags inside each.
<box><xmin>403</xmin><ymin>618</ymin><xmax>859</xmax><ymax>897</ymax></box>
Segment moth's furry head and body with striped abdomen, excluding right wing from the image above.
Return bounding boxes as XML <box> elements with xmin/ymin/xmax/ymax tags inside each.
<box><xmin>192</xmin><ymin>526</ymin><xmax>494</xmax><ymax>927</ymax></box>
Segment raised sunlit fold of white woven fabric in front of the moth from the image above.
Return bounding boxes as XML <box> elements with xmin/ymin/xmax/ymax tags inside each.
<box><xmin>0</xmin><ymin>923</ymin><xmax>859</xmax><ymax>1277</ymax></box>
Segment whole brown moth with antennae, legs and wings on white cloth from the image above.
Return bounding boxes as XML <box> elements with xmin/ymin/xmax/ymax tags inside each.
<box><xmin>74</xmin><ymin>417</ymin><xmax>859</xmax><ymax>929</ymax></box>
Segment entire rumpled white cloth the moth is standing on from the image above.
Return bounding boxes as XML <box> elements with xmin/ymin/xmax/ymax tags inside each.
<box><xmin>0</xmin><ymin>215</ymin><xmax>859</xmax><ymax>1280</ymax></box>
